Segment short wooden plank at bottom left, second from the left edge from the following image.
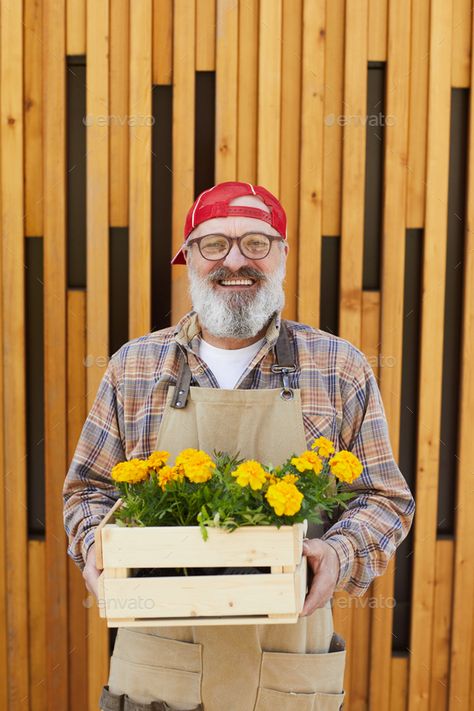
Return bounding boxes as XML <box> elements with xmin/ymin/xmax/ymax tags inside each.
<box><xmin>28</xmin><ymin>540</ymin><xmax>46</xmax><ymax>711</ymax></box>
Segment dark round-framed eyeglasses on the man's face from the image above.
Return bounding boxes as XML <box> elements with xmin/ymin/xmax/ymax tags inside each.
<box><xmin>186</xmin><ymin>232</ymin><xmax>284</xmax><ymax>262</ymax></box>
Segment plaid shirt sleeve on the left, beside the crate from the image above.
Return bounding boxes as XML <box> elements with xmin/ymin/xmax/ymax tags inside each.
<box><xmin>63</xmin><ymin>358</ymin><xmax>125</xmax><ymax>570</ymax></box>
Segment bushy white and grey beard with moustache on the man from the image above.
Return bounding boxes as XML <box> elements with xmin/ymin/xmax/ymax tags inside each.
<box><xmin>188</xmin><ymin>254</ymin><xmax>285</xmax><ymax>338</ymax></box>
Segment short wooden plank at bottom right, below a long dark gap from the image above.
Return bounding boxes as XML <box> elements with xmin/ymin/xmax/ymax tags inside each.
<box><xmin>430</xmin><ymin>539</ymin><xmax>454</xmax><ymax>711</ymax></box>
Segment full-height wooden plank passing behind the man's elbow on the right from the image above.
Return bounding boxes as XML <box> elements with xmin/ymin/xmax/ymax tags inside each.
<box><xmin>370</xmin><ymin>0</ymin><xmax>411</xmax><ymax>711</ymax></box>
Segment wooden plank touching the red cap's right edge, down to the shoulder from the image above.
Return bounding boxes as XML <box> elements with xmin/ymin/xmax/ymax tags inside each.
<box><xmin>280</xmin><ymin>0</ymin><xmax>303</xmax><ymax>320</ymax></box>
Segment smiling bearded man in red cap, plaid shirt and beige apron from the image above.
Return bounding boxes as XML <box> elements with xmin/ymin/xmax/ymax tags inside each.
<box><xmin>64</xmin><ymin>182</ymin><xmax>415</xmax><ymax>711</ymax></box>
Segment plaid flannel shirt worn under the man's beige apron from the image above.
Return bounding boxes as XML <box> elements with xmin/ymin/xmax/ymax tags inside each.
<box><xmin>63</xmin><ymin>311</ymin><xmax>415</xmax><ymax>596</ymax></box>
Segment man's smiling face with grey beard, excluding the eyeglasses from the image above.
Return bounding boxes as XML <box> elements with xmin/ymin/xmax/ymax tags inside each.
<box><xmin>186</xmin><ymin>197</ymin><xmax>288</xmax><ymax>338</ymax></box>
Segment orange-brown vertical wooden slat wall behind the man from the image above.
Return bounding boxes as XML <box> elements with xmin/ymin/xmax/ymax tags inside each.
<box><xmin>0</xmin><ymin>0</ymin><xmax>474</xmax><ymax>711</ymax></box>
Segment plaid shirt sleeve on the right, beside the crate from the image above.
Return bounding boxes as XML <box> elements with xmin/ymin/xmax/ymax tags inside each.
<box><xmin>322</xmin><ymin>347</ymin><xmax>415</xmax><ymax>597</ymax></box>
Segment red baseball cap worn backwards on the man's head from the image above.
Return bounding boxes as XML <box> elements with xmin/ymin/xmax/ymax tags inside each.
<box><xmin>171</xmin><ymin>181</ymin><xmax>287</xmax><ymax>264</ymax></box>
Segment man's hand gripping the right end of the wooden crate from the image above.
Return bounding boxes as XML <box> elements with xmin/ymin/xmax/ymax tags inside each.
<box><xmin>300</xmin><ymin>538</ymin><xmax>339</xmax><ymax>617</ymax></box>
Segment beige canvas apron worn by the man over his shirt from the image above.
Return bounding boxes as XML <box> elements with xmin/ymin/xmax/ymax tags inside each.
<box><xmin>104</xmin><ymin>328</ymin><xmax>346</xmax><ymax>711</ymax></box>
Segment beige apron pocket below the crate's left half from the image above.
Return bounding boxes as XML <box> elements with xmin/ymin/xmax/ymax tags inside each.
<box><xmin>108</xmin><ymin>628</ymin><xmax>202</xmax><ymax>711</ymax></box>
